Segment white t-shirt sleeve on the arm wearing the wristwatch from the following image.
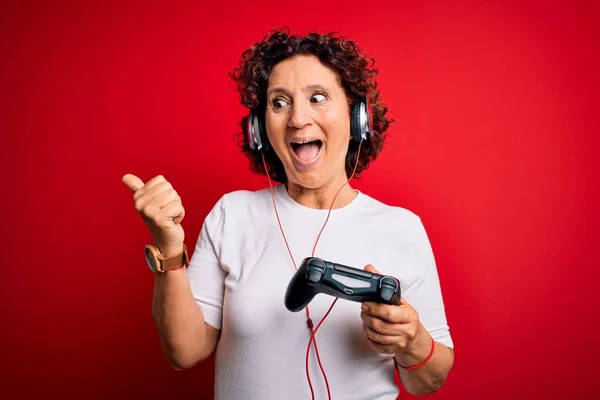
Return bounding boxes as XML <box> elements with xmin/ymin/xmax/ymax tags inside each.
<box><xmin>187</xmin><ymin>198</ymin><xmax>227</xmax><ymax>329</ymax></box>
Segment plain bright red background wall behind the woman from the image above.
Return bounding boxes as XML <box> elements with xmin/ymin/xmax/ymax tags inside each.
<box><xmin>0</xmin><ymin>0</ymin><xmax>600</xmax><ymax>399</ymax></box>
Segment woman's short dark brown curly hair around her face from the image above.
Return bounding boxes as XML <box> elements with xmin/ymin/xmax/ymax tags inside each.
<box><xmin>229</xmin><ymin>28</ymin><xmax>393</xmax><ymax>183</ymax></box>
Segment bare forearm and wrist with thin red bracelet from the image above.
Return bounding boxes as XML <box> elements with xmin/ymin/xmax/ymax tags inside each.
<box><xmin>396</xmin><ymin>324</ymin><xmax>454</xmax><ymax>396</ymax></box>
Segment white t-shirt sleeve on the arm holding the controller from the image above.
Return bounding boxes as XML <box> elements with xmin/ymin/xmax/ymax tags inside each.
<box><xmin>402</xmin><ymin>218</ymin><xmax>454</xmax><ymax>348</ymax></box>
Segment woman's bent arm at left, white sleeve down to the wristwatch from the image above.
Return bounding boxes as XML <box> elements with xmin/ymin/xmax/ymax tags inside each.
<box><xmin>158</xmin><ymin>195</ymin><xmax>227</xmax><ymax>370</ymax></box>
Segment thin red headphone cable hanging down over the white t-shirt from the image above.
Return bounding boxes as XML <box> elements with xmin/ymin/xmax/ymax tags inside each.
<box><xmin>261</xmin><ymin>142</ymin><xmax>362</xmax><ymax>400</ymax></box>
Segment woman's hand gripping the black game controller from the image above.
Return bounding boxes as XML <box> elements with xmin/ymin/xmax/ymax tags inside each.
<box><xmin>360</xmin><ymin>265</ymin><xmax>422</xmax><ymax>354</ymax></box>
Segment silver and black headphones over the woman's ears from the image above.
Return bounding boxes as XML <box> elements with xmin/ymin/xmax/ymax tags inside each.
<box><xmin>246</xmin><ymin>96</ymin><xmax>373</xmax><ymax>152</ymax></box>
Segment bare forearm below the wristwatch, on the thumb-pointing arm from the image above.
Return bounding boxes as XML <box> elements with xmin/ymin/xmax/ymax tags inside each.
<box><xmin>152</xmin><ymin>268</ymin><xmax>206</xmax><ymax>369</ymax></box>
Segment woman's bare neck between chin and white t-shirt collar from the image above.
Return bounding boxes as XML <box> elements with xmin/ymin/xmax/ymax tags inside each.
<box><xmin>285</xmin><ymin>176</ymin><xmax>358</xmax><ymax>210</ymax></box>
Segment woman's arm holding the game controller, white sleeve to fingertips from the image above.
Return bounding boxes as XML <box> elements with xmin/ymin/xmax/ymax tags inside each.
<box><xmin>361</xmin><ymin>216</ymin><xmax>454</xmax><ymax>395</ymax></box>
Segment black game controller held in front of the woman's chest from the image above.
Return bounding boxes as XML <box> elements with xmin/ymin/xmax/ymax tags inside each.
<box><xmin>285</xmin><ymin>257</ymin><xmax>400</xmax><ymax>312</ymax></box>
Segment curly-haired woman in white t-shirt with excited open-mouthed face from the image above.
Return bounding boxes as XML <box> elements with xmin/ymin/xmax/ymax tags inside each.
<box><xmin>123</xmin><ymin>31</ymin><xmax>454</xmax><ymax>399</ymax></box>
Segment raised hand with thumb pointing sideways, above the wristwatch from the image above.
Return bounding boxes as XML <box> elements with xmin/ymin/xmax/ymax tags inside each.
<box><xmin>122</xmin><ymin>174</ymin><xmax>185</xmax><ymax>257</ymax></box>
